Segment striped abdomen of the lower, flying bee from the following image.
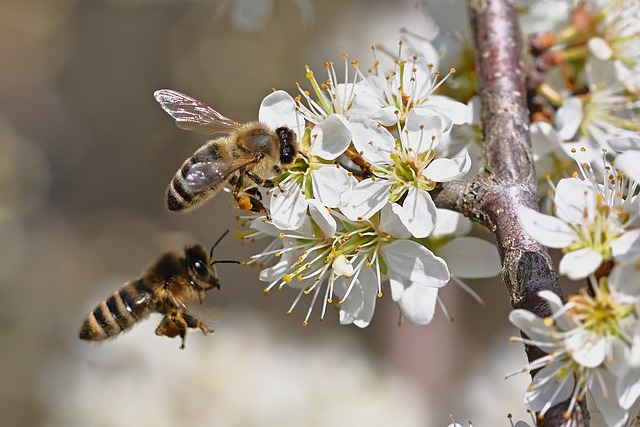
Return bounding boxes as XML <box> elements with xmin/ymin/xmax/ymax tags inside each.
<box><xmin>80</xmin><ymin>279</ymin><xmax>154</xmax><ymax>341</ymax></box>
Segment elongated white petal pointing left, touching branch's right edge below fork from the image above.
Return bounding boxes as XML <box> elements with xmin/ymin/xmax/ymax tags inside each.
<box><xmin>518</xmin><ymin>206</ymin><xmax>576</xmax><ymax>248</ymax></box>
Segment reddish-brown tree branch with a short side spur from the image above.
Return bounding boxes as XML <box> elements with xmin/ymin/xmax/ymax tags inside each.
<box><xmin>433</xmin><ymin>0</ymin><xmax>589</xmax><ymax>427</ymax></box>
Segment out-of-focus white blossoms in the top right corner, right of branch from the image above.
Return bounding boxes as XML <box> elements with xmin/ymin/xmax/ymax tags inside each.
<box><xmin>529</xmin><ymin>0</ymin><xmax>640</xmax><ymax>182</ymax></box>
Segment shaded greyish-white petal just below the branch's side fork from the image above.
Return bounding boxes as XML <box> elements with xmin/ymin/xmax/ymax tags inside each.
<box><xmin>438</xmin><ymin>236</ymin><xmax>502</xmax><ymax>279</ymax></box>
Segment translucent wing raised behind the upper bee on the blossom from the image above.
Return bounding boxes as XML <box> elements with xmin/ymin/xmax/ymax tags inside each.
<box><xmin>153</xmin><ymin>89</ymin><xmax>242</xmax><ymax>135</ymax></box>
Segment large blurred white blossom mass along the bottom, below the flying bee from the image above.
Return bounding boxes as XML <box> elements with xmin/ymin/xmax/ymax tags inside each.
<box><xmin>38</xmin><ymin>307</ymin><xmax>430</xmax><ymax>427</ymax></box>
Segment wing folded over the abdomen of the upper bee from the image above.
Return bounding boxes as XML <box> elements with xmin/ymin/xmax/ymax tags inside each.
<box><xmin>183</xmin><ymin>157</ymin><xmax>257</xmax><ymax>192</ymax></box>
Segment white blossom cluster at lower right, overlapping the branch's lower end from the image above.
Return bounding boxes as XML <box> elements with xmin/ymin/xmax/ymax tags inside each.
<box><xmin>510</xmin><ymin>150</ymin><xmax>640</xmax><ymax>426</ymax></box>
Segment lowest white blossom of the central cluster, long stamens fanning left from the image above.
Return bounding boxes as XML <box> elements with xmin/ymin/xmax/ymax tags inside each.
<box><xmin>246</xmin><ymin>200</ymin><xmax>449</xmax><ymax>327</ymax></box>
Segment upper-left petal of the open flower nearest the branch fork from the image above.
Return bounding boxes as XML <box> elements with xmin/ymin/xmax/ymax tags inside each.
<box><xmin>349</xmin><ymin>116</ymin><xmax>395</xmax><ymax>164</ymax></box>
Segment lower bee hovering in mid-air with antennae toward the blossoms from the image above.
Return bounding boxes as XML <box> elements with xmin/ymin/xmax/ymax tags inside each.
<box><xmin>79</xmin><ymin>230</ymin><xmax>238</xmax><ymax>349</ymax></box>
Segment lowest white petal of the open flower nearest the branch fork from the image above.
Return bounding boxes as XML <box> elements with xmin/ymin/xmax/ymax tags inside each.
<box><xmin>392</xmin><ymin>187</ymin><xmax>437</xmax><ymax>238</ymax></box>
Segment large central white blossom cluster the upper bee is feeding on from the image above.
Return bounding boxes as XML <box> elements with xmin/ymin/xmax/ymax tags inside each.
<box><xmin>238</xmin><ymin>43</ymin><xmax>499</xmax><ymax>327</ymax></box>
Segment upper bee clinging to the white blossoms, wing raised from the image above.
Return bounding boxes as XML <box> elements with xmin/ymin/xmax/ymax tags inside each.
<box><xmin>154</xmin><ymin>89</ymin><xmax>298</xmax><ymax>213</ymax></box>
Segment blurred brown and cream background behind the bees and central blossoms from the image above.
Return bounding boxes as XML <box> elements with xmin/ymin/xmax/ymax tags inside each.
<box><xmin>0</xmin><ymin>0</ymin><xmax>540</xmax><ymax>427</ymax></box>
